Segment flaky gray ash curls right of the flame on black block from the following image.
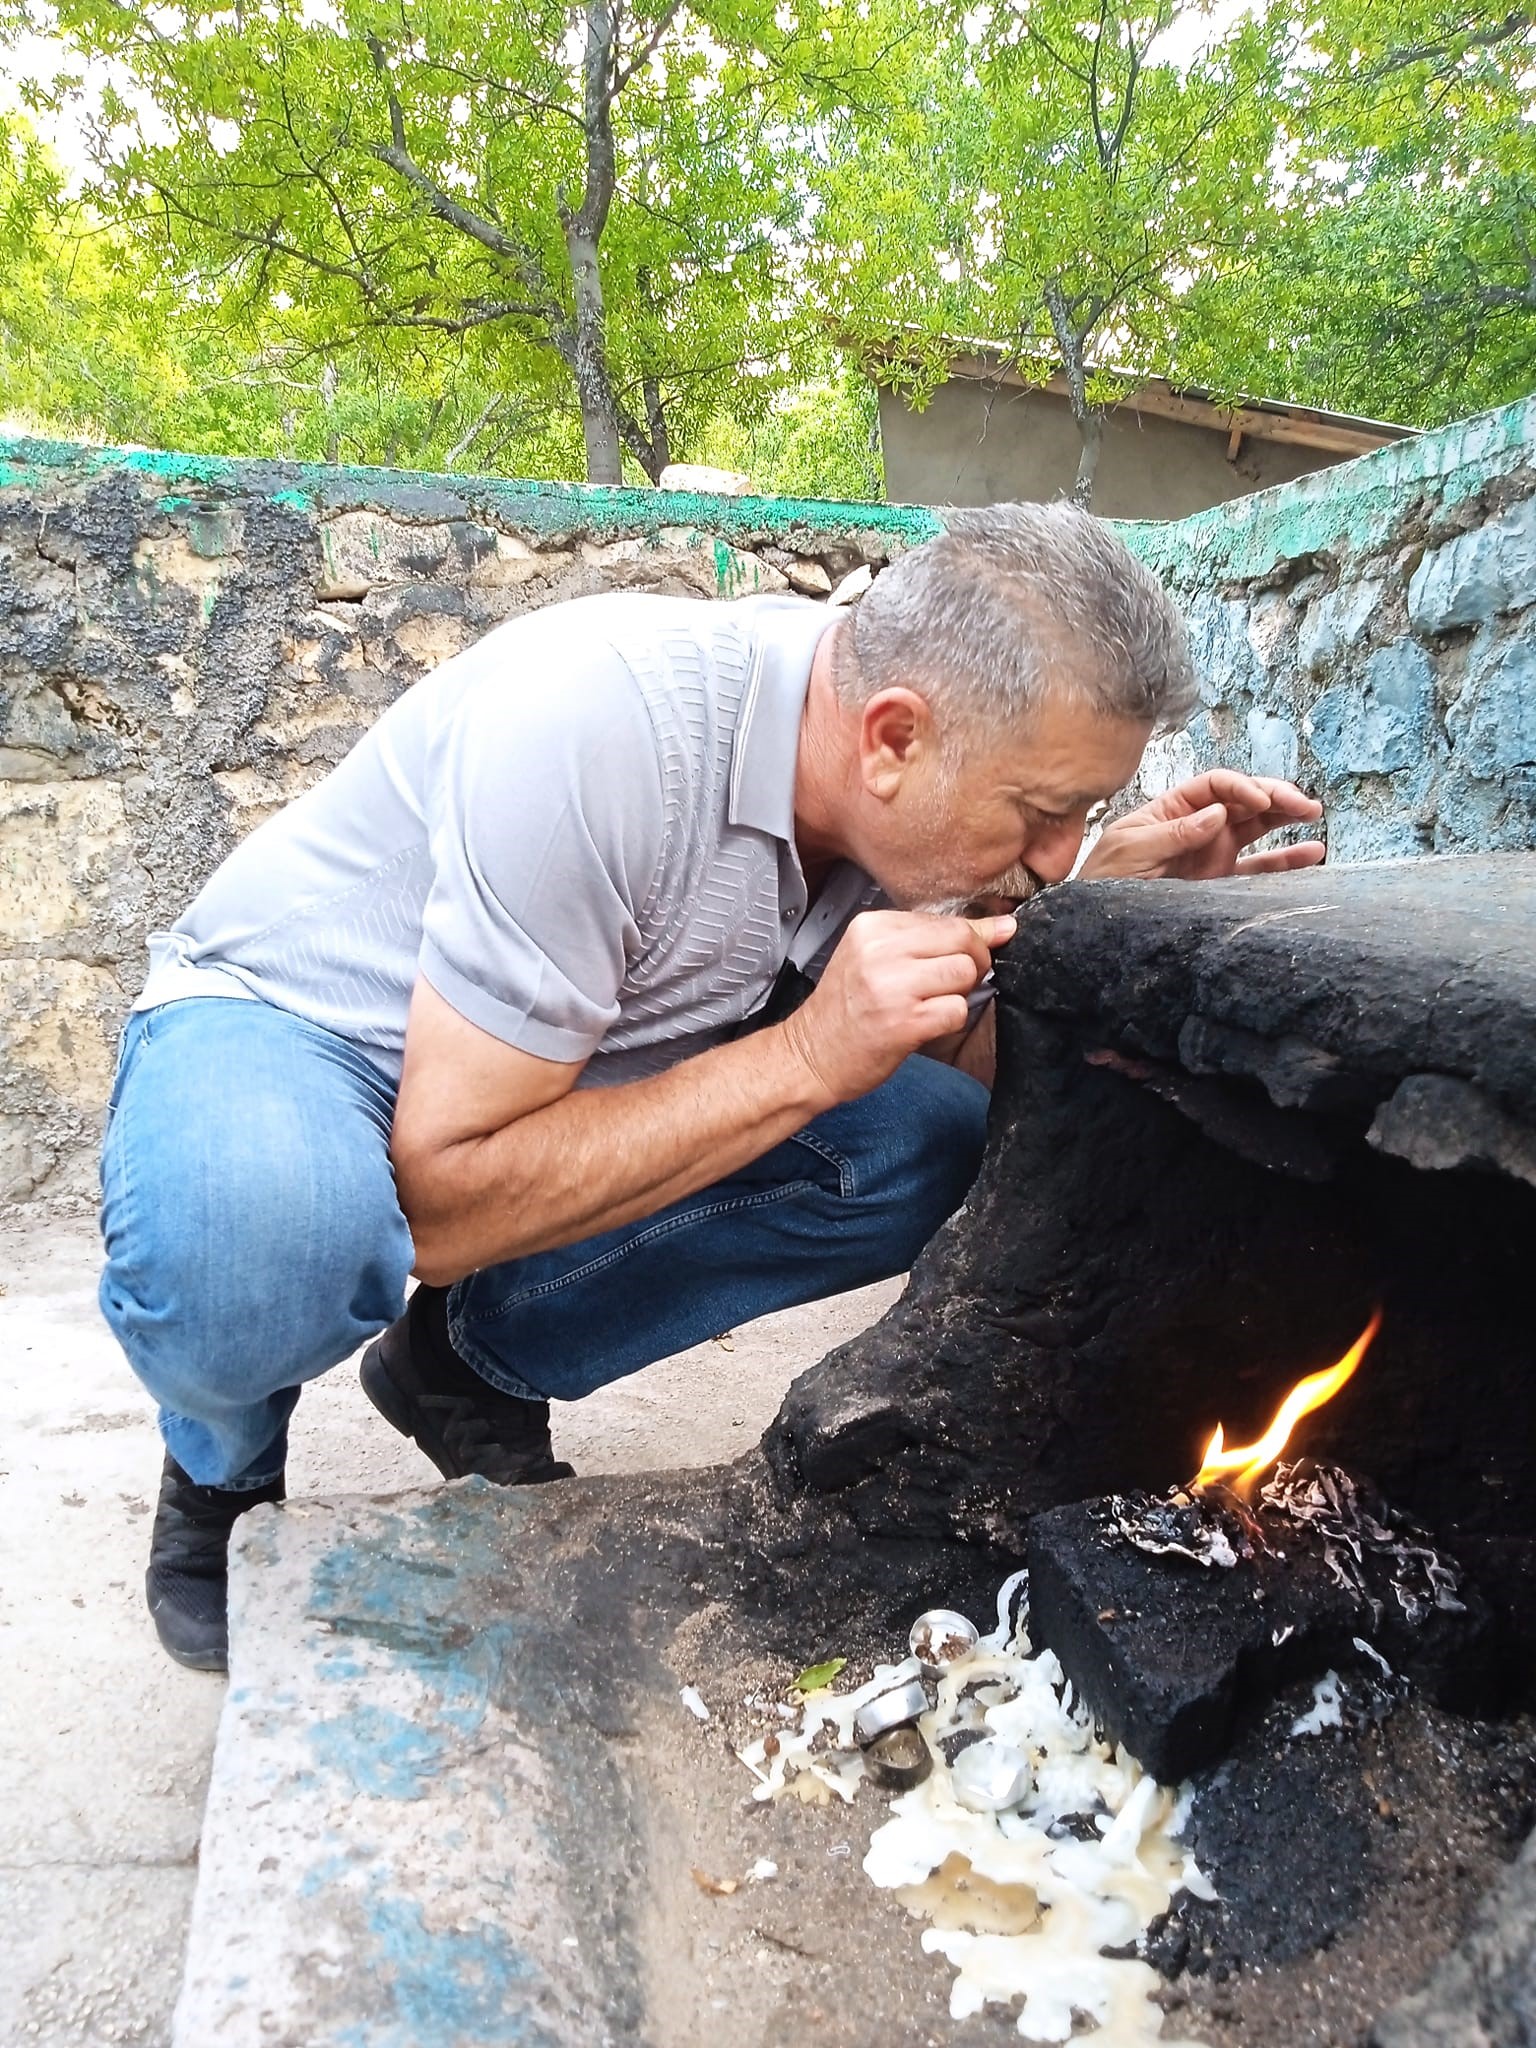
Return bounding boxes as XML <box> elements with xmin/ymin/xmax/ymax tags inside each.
<box><xmin>1260</xmin><ymin>1458</ymin><xmax>1466</xmax><ymax>1628</ymax></box>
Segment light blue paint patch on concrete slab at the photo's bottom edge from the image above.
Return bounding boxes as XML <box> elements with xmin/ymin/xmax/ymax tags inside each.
<box><xmin>334</xmin><ymin>1896</ymin><xmax>555</xmax><ymax>2048</ymax></box>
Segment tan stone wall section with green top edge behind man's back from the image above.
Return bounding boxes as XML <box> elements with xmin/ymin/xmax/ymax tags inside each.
<box><xmin>0</xmin><ymin>440</ymin><xmax>936</xmax><ymax>1200</ymax></box>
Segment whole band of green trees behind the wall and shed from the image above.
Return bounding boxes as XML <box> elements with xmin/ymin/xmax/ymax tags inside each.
<box><xmin>0</xmin><ymin>0</ymin><xmax>1536</xmax><ymax>498</ymax></box>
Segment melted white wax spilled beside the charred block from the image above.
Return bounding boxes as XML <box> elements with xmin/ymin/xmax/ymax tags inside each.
<box><xmin>741</xmin><ymin>1575</ymin><xmax>1214</xmax><ymax>2048</ymax></box>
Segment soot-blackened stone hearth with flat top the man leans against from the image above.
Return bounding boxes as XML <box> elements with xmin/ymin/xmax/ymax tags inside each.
<box><xmin>766</xmin><ymin>854</ymin><xmax>1536</xmax><ymax>1662</ymax></box>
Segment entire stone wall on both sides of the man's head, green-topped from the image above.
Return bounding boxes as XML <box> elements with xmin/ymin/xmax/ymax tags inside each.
<box><xmin>0</xmin><ymin>406</ymin><xmax>1536</xmax><ymax>1200</ymax></box>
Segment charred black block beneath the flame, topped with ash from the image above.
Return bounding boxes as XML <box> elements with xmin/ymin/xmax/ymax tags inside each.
<box><xmin>1028</xmin><ymin>1466</ymin><xmax>1501</xmax><ymax>1782</ymax></box>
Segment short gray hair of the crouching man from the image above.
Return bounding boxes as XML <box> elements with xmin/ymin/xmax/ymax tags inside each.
<box><xmin>834</xmin><ymin>504</ymin><xmax>1198</xmax><ymax>733</ymax></box>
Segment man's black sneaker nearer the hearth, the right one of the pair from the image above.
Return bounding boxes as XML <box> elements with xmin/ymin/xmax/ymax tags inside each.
<box><xmin>360</xmin><ymin>1286</ymin><xmax>575</xmax><ymax>1487</ymax></box>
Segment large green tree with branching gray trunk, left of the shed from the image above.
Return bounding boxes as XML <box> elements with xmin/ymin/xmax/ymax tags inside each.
<box><xmin>0</xmin><ymin>0</ymin><xmax>866</xmax><ymax>483</ymax></box>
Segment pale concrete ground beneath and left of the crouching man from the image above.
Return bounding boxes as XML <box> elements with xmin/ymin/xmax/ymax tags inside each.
<box><xmin>0</xmin><ymin>1210</ymin><xmax>899</xmax><ymax>2048</ymax></box>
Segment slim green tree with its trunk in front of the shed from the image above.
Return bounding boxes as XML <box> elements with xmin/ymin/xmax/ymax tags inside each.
<box><xmin>817</xmin><ymin>0</ymin><xmax>1292</xmax><ymax>504</ymax></box>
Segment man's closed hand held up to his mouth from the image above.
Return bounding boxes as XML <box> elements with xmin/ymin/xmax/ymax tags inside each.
<box><xmin>778</xmin><ymin>909</ymin><xmax>1018</xmax><ymax>1106</ymax></box>
